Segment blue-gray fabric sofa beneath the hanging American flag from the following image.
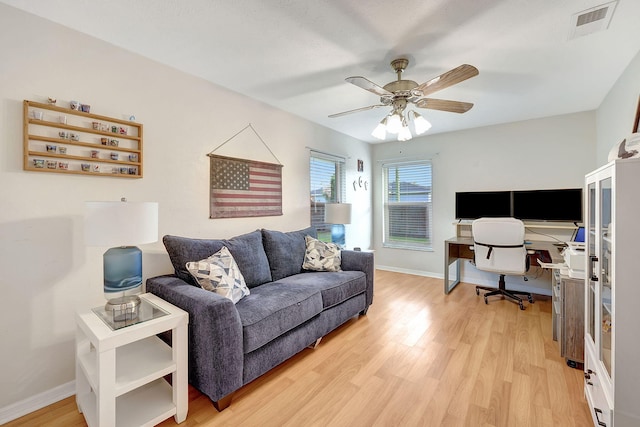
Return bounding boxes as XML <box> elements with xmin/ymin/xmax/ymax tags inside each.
<box><xmin>147</xmin><ymin>228</ymin><xmax>374</xmax><ymax>411</ymax></box>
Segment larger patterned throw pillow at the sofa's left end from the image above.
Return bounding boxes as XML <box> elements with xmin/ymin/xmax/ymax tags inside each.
<box><xmin>187</xmin><ymin>246</ymin><xmax>249</xmax><ymax>304</ymax></box>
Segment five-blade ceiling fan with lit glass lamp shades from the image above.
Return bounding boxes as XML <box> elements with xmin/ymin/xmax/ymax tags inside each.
<box><xmin>329</xmin><ymin>58</ymin><xmax>478</xmax><ymax>141</ymax></box>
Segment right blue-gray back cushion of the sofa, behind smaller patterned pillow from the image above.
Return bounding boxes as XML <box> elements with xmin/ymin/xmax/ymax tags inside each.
<box><xmin>262</xmin><ymin>227</ymin><xmax>318</xmax><ymax>281</ymax></box>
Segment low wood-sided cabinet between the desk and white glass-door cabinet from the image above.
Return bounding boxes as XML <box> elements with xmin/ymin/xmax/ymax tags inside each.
<box><xmin>551</xmin><ymin>269</ymin><xmax>584</xmax><ymax>368</ymax></box>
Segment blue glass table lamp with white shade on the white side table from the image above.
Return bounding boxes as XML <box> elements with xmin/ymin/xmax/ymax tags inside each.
<box><xmin>85</xmin><ymin>198</ymin><xmax>158</xmax><ymax>321</ymax></box>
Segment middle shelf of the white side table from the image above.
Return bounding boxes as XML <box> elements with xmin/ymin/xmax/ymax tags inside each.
<box><xmin>80</xmin><ymin>336</ymin><xmax>176</xmax><ymax>396</ymax></box>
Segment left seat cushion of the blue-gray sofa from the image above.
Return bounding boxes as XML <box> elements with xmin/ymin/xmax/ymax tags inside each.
<box><xmin>236</xmin><ymin>283</ymin><xmax>322</xmax><ymax>354</ymax></box>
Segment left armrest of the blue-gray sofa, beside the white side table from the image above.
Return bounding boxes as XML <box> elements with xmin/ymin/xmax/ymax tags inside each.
<box><xmin>147</xmin><ymin>275</ymin><xmax>244</xmax><ymax>402</ymax></box>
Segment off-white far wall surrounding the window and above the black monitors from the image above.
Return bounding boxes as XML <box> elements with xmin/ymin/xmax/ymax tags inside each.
<box><xmin>373</xmin><ymin>112</ymin><xmax>596</xmax><ymax>294</ymax></box>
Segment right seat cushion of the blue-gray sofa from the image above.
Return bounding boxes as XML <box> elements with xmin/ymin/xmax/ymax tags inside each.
<box><xmin>276</xmin><ymin>271</ymin><xmax>367</xmax><ymax>309</ymax></box>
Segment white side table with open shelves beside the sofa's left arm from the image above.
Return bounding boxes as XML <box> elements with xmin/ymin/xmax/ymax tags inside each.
<box><xmin>76</xmin><ymin>293</ymin><xmax>189</xmax><ymax>427</ymax></box>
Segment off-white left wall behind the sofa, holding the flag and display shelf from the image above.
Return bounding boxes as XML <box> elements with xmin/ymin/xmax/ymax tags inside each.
<box><xmin>0</xmin><ymin>4</ymin><xmax>372</xmax><ymax>416</ymax></box>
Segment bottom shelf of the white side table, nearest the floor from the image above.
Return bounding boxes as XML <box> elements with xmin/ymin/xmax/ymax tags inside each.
<box><xmin>78</xmin><ymin>378</ymin><xmax>176</xmax><ymax>427</ymax></box>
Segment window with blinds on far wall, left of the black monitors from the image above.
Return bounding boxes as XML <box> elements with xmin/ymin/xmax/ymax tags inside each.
<box><xmin>382</xmin><ymin>160</ymin><xmax>433</xmax><ymax>250</ymax></box>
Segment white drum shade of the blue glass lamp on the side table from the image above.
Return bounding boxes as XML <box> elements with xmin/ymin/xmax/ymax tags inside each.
<box><xmin>84</xmin><ymin>201</ymin><xmax>158</xmax><ymax>246</ymax></box>
